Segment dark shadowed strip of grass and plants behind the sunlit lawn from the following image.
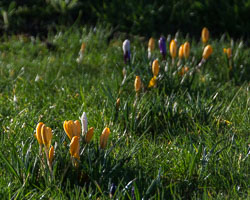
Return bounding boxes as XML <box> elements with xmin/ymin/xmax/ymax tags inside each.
<box><xmin>0</xmin><ymin>0</ymin><xmax>250</xmax><ymax>39</ymax></box>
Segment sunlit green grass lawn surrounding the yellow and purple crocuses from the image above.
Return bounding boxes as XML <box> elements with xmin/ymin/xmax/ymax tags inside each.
<box><xmin>0</xmin><ymin>27</ymin><xmax>250</xmax><ymax>199</ymax></box>
